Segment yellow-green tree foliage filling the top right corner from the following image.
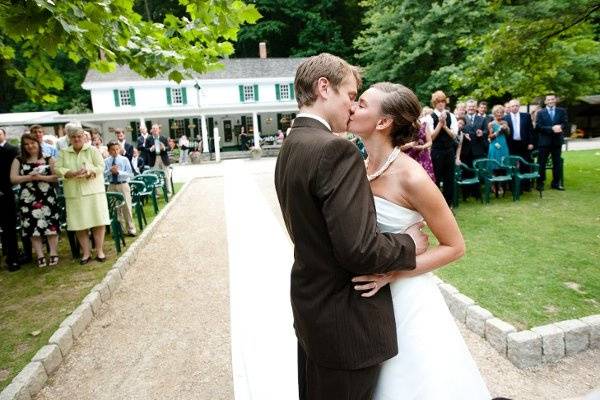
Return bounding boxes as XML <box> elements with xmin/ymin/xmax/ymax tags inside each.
<box><xmin>451</xmin><ymin>0</ymin><xmax>600</xmax><ymax>100</ymax></box>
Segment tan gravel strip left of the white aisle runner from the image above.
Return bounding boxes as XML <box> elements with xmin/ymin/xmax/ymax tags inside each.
<box><xmin>37</xmin><ymin>178</ymin><xmax>233</xmax><ymax>400</ymax></box>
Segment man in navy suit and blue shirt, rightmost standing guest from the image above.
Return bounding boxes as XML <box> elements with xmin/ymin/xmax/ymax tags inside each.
<box><xmin>535</xmin><ymin>94</ymin><xmax>568</xmax><ymax>190</ymax></box>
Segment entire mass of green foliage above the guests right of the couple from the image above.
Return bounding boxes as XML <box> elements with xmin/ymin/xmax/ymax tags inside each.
<box><xmin>354</xmin><ymin>0</ymin><xmax>600</xmax><ymax>102</ymax></box>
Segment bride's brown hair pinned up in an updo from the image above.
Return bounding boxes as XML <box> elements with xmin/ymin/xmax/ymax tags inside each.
<box><xmin>371</xmin><ymin>82</ymin><xmax>421</xmax><ymax>146</ymax></box>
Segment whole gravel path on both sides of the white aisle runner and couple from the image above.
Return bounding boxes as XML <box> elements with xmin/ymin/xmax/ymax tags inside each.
<box><xmin>37</xmin><ymin>159</ymin><xmax>600</xmax><ymax>400</ymax></box>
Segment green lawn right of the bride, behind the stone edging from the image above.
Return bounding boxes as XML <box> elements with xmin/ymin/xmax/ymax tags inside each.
<box><xmin>437</xmin><ymin>150</ymin><xmax>600</xmax><ymax>329</ymax></box>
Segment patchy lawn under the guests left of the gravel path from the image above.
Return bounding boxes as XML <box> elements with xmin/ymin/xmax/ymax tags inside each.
<box><xmin>0</xmin><ymin>184</ymin><xmax>182</xmax><ymax>390</ymax></box>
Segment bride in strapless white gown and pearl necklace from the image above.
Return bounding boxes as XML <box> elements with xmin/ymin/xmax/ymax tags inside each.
<box><xmin>348</xmin><ymin>82</ymin><xmax>491</xmax><ymax>400</ymax></box>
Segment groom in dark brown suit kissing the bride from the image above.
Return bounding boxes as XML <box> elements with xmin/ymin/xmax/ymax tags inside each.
<box><xmin>275</xmin><ymin>53</ymin><xmax>428</xmax><ymax>400</ymax></box>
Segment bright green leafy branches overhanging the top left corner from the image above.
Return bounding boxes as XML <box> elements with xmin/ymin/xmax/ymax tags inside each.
<box><xmin>0</xmin><ymin>0</ymin><xmax>260</xmax><ymax>102</ymax></box>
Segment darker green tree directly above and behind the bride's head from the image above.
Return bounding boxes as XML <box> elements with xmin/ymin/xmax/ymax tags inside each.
<box><xmin>354</xmin><ymin>0</ymin><xmax>495</xmax><ymax>102</ymax></box>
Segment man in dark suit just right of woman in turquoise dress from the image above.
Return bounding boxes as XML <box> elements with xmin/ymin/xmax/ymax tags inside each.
<box><xmin>504</xmin><ymin>99</ymin><xmax>534</xmax><ymax>190</ymax></box>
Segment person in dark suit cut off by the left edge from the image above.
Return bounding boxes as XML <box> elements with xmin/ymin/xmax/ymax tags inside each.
<box><xmin>0</xmin><ymin>128</ymin><xmax>20</xmax><ymax>272</ymax></box>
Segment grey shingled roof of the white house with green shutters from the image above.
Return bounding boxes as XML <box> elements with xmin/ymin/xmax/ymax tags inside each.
<box><xmin>84</xmin><ymin>58</ymin><xmax>306</xmax><ymax>83</ymax></box>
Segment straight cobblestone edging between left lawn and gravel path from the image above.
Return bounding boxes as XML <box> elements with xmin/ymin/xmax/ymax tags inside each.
<box><xmin>0</xmin><ymin>180</ymin><xmax>193</xmax><ymax>400</ymax></box>
